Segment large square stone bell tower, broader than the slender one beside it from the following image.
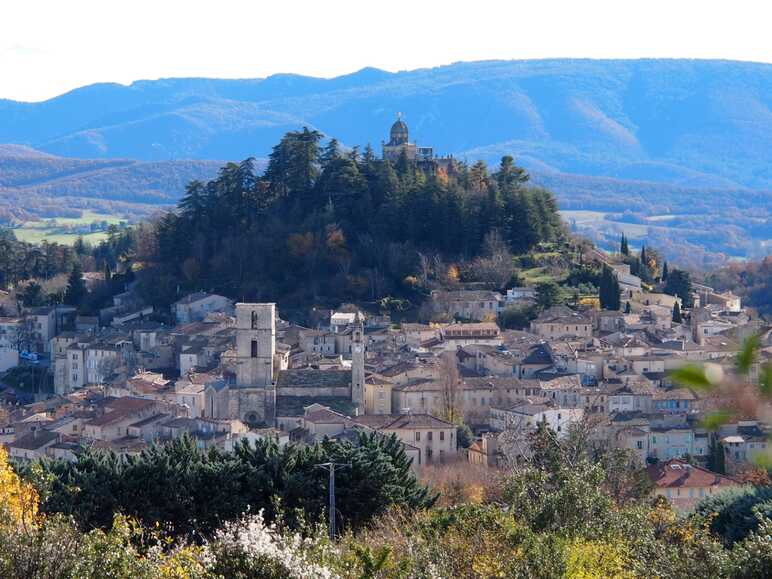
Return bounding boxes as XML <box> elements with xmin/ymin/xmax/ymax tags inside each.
<box><xmin>230</xmin><ymin>304</ymin><xmax>276</xmax><ymax>426</ymax></box>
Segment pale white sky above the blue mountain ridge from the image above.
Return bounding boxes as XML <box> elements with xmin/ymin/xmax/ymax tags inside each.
<box><xmin>0</xmin><ymin>0</ymin><xmax>772</xmax><ymax>100</ymax></box>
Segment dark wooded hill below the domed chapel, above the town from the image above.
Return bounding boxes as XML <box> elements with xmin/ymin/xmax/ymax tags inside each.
<box><xmin>137</xmin><ymin>129</ymin><xmax>565</xmax><ymax>304</ymax></box>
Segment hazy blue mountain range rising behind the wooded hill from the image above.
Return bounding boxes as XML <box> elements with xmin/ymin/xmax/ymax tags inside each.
<box><xmin>0</xmin><ymin>59</ymin><xmax>772</xmax><ymax>262</ymax></box>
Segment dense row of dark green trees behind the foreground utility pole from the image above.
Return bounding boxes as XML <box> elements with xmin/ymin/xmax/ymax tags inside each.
<box><xmin>39</xmin><ymin>432</ymin><xmax>436</xmax><ymax>537</ymax></box>
